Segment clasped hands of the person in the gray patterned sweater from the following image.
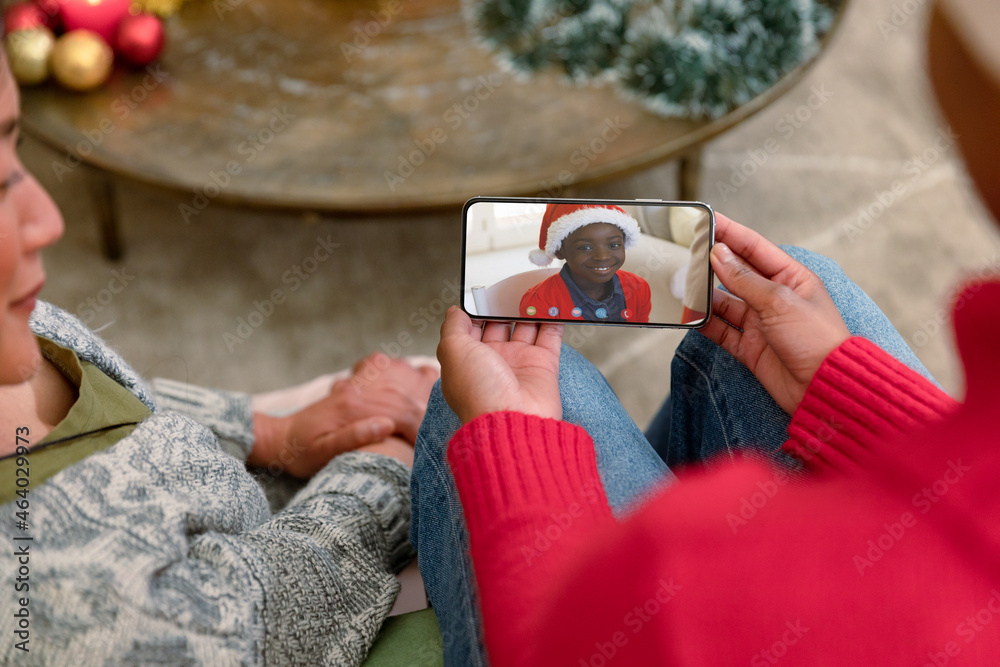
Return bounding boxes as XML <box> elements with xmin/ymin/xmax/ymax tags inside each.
<box><xmin>247</xmin><ymin>353</ymin><xmax>438</xmax><ymax>478</ymax></box>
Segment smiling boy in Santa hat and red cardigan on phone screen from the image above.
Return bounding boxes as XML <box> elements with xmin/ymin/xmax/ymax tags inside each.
<box><xmin>520</xmin><ymin>204</ymin><xmax>650</xmax><ymax>322</ymax></box>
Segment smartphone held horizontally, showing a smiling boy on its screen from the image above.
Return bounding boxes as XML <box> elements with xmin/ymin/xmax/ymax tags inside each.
<box><xmin>461</xmin><ymin>197</ymin><xmax>715</xmax><ymax>329</ymax></box>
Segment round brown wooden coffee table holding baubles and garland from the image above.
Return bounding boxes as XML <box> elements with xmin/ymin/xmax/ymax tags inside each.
<box><xmin>22</xmin><ymin>0</ymin><xmax>846</xmax><ymax>258</ymax></box>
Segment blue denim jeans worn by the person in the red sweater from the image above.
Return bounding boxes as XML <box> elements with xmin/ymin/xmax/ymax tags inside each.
<box><xmin>410</xmin><ymin>247</ymin><xmax>933</xmax><ymax>667</ymax></box>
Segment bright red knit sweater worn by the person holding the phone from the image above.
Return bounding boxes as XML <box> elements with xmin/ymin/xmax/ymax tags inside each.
<box><xmin>449</xmin><ymin>283</ymin><xmax>1000</xmax><ymax>667</ymax></box>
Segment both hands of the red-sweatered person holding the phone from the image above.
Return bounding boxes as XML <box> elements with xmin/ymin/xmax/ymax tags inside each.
<box><xmin>438</xmin><ymin>214</ymin><xmax>850</xmax><ymax>423</ymax></box>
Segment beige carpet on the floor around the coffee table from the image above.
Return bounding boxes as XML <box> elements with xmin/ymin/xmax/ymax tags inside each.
<box><xmin>22</xmin><ymin>0</ymin><xmax>998</xmax><ymax>425</ymax></box>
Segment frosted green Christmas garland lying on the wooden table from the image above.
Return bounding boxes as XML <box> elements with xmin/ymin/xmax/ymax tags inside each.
<box><xmin>466</xmin><ymin>0</ymin><xmax>840</xmax><ymax>118</ymax></box>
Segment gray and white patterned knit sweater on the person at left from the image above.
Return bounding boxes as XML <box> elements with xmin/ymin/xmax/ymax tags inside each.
<box><xmin>0</xmin><ymin>303</ymin><xmax>412</xmax><ymax>665</ymax></box>
